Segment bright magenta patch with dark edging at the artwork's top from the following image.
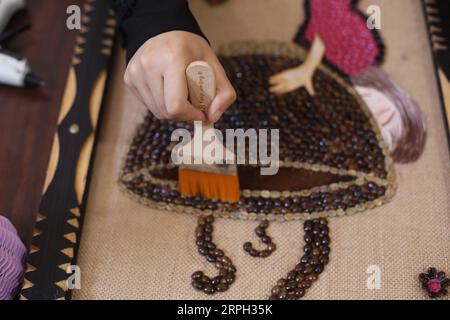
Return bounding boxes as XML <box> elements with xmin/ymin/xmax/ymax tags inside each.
<box><xmin>303</xmin><ymin>0</ymin><xmax>380</xmax><ymax>76</ymax></box>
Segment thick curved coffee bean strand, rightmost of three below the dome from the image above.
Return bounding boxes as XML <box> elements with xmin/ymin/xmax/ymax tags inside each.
<box><xmin>270</xmin><ymin>218</ymin><xmax>330</xmax><ymax>300</ymax></box>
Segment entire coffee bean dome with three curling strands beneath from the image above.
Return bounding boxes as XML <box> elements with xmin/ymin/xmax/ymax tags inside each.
<box><xmin>119</xmin><ymin>42</ymin><xmax>395</xmax><ymax>299</ymax></box>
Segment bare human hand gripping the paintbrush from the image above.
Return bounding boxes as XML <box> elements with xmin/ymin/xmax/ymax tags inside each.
<box><xmin>124</xmin><ymin>31</ymin><xmax>236</xmax><ymax>122</ymax></box>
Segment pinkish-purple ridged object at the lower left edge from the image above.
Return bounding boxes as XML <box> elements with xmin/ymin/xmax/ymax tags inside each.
<box><xmin>0</xmin><ymin>216</ymin><xmax>27</xmax><ymax>300</ymax></box>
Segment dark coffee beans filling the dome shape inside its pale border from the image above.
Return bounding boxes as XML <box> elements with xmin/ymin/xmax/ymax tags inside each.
<box><xmin>122</xmin><ymin>54</ymin><xmax>387</xmax><ymax>215</ymax></box>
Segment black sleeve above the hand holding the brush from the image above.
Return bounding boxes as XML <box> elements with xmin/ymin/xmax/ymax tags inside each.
<box><xmin>109</xmin><ymin>0</ymin><xmax>206</xmax><ymax>61</ymax></box>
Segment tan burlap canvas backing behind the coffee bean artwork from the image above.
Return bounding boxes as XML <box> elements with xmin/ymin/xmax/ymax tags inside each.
<box><xmin>74</xmin><ymin>0</ymin><xmax>450</xmax><ymax>299</ymax></box>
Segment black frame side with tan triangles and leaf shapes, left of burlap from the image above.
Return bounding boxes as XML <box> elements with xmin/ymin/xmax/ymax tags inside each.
<box><xmin>20</xmin><ymin>0</ymin><xmax>116</xmax><ymax>300</ymax></box>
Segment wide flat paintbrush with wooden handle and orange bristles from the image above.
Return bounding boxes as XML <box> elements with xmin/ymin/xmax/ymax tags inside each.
<box><xmin>178</xmin><ymin>61</ymin><xmax>240</xmax><ymax>202</ymax></box>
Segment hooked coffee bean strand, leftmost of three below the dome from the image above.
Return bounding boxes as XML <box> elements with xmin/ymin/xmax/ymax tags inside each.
<box><xmin>192</xmin><ymin>215</ymin><xmax>236</xmax><ymax>294</ymax></box>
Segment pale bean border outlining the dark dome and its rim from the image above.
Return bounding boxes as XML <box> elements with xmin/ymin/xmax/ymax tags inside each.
<box><xmin>118</xmin><ymin>41</ymin><xmax>397</xmax><ymax>221</ymax></box>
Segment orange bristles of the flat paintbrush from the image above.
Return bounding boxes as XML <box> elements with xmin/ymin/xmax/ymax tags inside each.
<box><xmin>178</xmin><ymin>168</ymin><xmax>240</xmax><ymax>202</ymax></box>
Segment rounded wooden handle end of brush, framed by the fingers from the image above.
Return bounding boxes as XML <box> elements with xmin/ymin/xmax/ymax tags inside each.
<box><xmin>186</xmin><ymin>61</ymin><xmax>216</xmax><ymax>112</ymax></box>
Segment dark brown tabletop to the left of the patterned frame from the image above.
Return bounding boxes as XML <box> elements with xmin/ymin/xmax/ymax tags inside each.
<box><xmin>0</xmin><ymin>0</ymin><xmax>84</xmax><ymax>243</ymax></box>
